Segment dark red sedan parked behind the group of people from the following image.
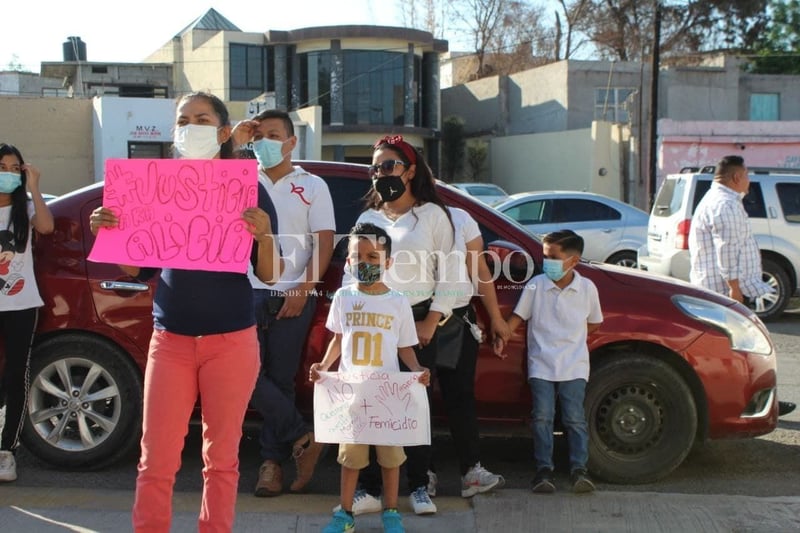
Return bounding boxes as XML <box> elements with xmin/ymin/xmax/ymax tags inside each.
<box><xmin>9</xmin><ymin>162</ymin><xmax>778</xmax><ymax>483</ymax></box>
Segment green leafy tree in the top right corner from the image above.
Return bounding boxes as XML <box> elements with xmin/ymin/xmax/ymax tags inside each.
<box><xmin>750</xmin><ymin>0</ymin><xmax>800</xmax><ymax>74</ymax></box>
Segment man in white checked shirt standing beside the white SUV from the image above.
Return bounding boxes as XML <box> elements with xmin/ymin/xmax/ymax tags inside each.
<box><xmin>689</xmin><ymin>155</ymin><xmax>772</xmax><ymax>302</ymax></box>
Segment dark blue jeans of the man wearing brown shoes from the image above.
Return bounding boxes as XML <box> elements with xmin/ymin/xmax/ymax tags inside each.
<box><xmin>251</xmin><ymin>289</ymin><xmax>317</xmax><ymax>462</ymax></box>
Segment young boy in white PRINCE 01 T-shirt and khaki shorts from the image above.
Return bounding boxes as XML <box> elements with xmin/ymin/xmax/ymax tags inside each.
<box><xmin>309</xmin><ymin>223</ymin><xmax>430</xmax><ymax>533</ymax></box>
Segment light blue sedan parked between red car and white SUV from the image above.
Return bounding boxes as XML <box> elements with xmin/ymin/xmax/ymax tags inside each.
<box><xmin>494</xmin><ymin>191</ymin><xmax>648</xmax><ymax>267</ymax></box>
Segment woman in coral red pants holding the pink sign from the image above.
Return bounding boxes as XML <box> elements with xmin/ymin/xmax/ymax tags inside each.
<box><xmin>90</xmin><ymin>93</ymin><xmax>282</xmax><ymax>532</ymax></box>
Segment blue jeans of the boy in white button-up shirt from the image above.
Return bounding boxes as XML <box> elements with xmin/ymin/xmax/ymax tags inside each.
<box><xmin>528</xmin><ymin>378</ymin><xmax>589</xmax><ymax>472</ymax></box>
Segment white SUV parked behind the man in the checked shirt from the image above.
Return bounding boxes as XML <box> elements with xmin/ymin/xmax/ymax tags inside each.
<box><xmin>638</xmin><ymin>167</ymin><xmax>800</xmax><ymax>320</ymax></box>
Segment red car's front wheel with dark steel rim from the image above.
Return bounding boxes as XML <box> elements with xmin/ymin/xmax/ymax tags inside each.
<box><xmin>586</xmin><ymin>353</ymin><xmax>697</xmax><ymax>483</ymax></box>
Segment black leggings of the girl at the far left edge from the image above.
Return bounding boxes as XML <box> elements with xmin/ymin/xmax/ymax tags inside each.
<box><xmin>0</xmin><ymin>307</ymin><xmax>39</xmax><ymax>451</ymax></box>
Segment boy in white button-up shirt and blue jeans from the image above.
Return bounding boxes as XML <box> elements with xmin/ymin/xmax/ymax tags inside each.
<box><xmin>495</xmin><ymin>230</ymin><xmax>603</xmax><ymax>493</ymax></box>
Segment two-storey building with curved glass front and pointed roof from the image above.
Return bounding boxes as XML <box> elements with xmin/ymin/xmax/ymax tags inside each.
<box><xmin>145</xmin><ymin>9</ymin><xmax>447</xmax><ymax>168</ymax></box>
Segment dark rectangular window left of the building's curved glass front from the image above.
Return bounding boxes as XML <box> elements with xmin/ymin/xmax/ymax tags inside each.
<box><xmin>230</xmin><ymin>44</ymin><xmax>274</xmax><ymax>102</ymax></box>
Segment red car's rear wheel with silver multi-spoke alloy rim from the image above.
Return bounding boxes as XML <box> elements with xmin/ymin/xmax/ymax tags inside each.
<box><xmin>22</xmin><ymin>335</ymin><xmax>142</xmax><ymax>468</ymax></box>
